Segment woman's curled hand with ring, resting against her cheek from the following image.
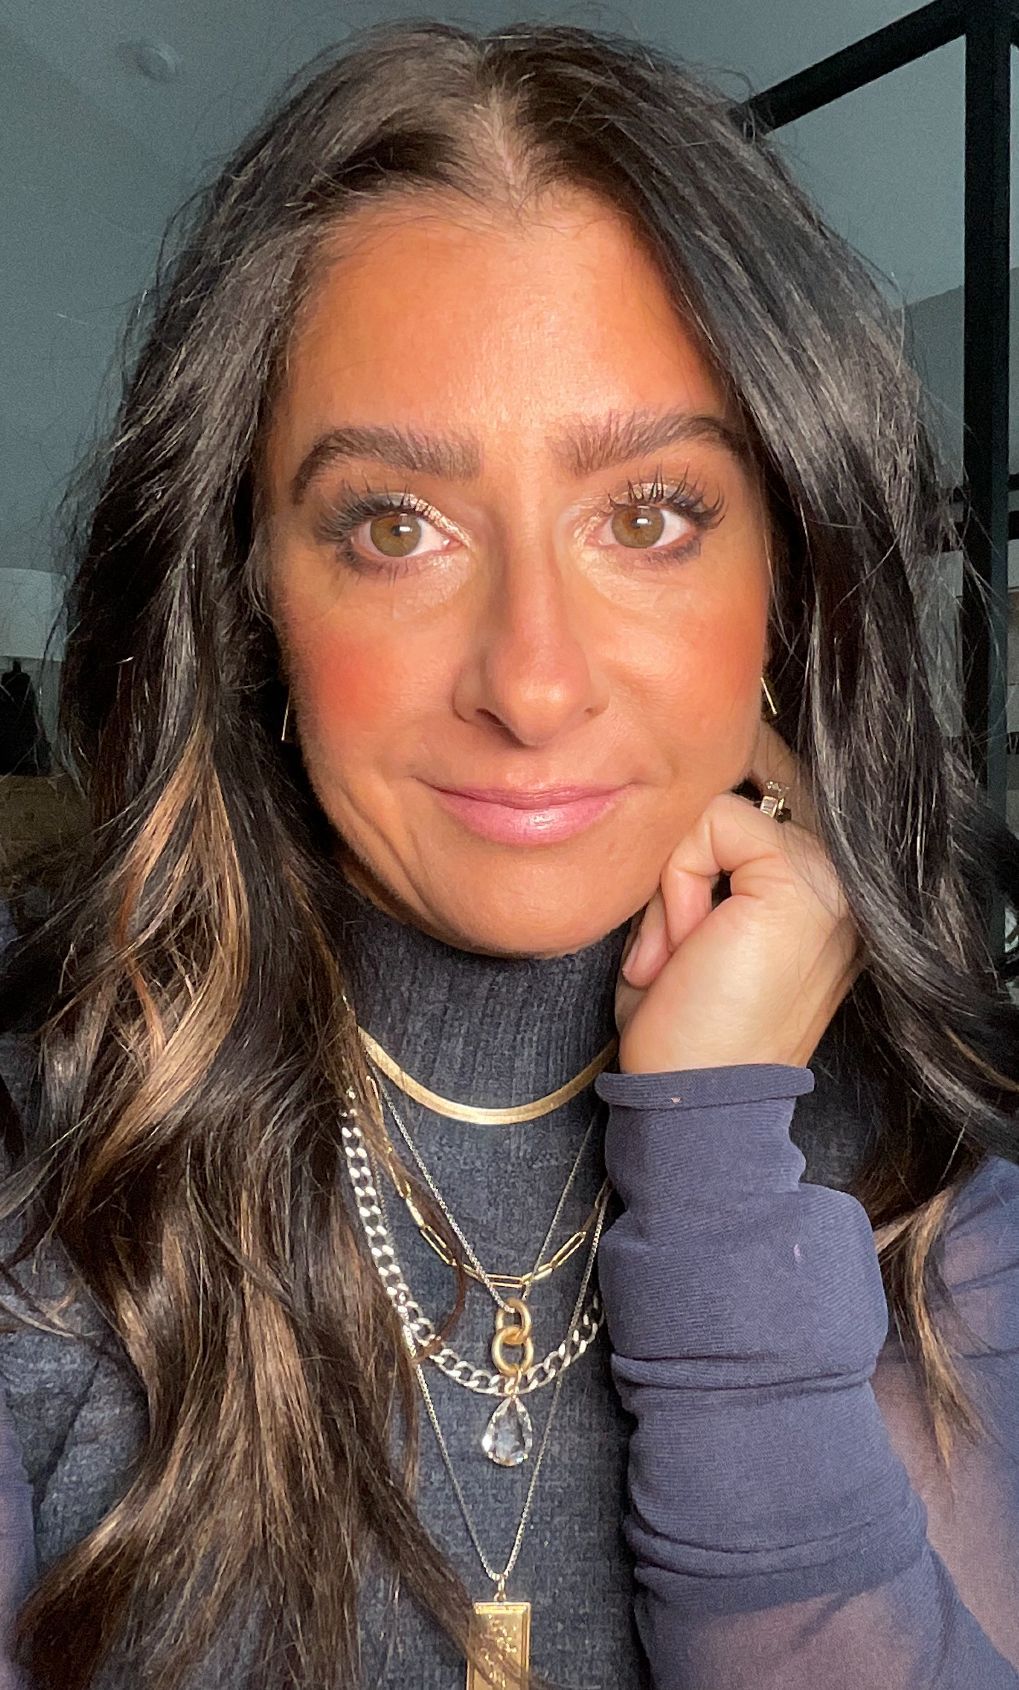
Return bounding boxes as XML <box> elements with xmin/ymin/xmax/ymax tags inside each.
<box><xmin>615</xmin><ymin>720</ymin><xmax>862</xmax><ymax>1073</ymax></box>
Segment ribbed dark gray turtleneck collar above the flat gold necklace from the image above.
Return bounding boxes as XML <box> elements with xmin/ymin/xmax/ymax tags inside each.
<box><xmin>326</xmin><ymin>858</ymin><xmax>629</xmax><ymax>1107</ymax></box>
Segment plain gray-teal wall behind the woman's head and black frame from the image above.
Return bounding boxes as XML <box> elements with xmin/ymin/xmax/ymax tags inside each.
<box><xmin>0</xmin><ymin>0</ymin><xmax>1019</xmax><ymax>753</ymax></box>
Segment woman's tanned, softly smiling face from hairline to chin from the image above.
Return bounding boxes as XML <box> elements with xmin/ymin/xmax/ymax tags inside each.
<box><xmin>260</xmin><ymin>193</ymin><xmax>769</xmax><ymax>957</ymax></box>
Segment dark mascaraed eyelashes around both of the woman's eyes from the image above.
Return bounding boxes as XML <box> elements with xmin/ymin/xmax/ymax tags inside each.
<box><xmin>314</xmin><ymin>468</ymin><xmax>725</xmax><ymax>580</ymax></box>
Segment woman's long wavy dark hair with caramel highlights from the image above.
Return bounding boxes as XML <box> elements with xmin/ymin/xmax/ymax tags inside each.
<box><xmin>0</xmin><ymin>19</ymin><xmax>1019</xmax><ymax>1690</ymax></box>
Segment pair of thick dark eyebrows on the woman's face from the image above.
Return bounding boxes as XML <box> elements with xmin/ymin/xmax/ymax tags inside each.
<box><xmin>291</xmin><ymin>411</ymin><xmax>752</xmax><ymax>505</ymax></box>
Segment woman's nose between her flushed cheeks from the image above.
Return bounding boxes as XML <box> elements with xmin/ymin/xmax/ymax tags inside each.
<box><xmin>455</xmin><ymin>527</ymin><xmax>607</xmax><ymax>745</ymax></box>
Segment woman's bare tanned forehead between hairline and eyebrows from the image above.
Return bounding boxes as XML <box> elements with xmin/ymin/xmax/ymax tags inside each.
<box><xmin>265</xmin><ymin>193</ymin><xmax>727</xmax><ymax>486</ymax></box>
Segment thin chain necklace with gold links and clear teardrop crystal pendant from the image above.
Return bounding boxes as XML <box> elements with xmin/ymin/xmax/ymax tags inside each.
<box><xmin>368</xmin><ymin>1075</ymin><xmax>608</xmax><ymax>1467</ymax></box>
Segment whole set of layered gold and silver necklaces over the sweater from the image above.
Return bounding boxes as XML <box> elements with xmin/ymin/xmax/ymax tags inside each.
<box><xmin>341</xmin><ymin>1029</ymin><xmax>618</xmax><ymax>1690</ymax></box>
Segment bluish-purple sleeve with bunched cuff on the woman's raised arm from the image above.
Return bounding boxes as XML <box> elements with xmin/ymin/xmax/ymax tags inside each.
<box><xmin>597</xmin><ymin>1063</ymin><xmax>1019</xmax><ymax>1690</ymax></box>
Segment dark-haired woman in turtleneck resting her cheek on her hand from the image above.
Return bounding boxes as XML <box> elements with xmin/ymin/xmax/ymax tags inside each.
<box><xmin>2</xmin><ymin>20</ymin><xmax>1019</xmax><ymax>1690</ymax></box>
